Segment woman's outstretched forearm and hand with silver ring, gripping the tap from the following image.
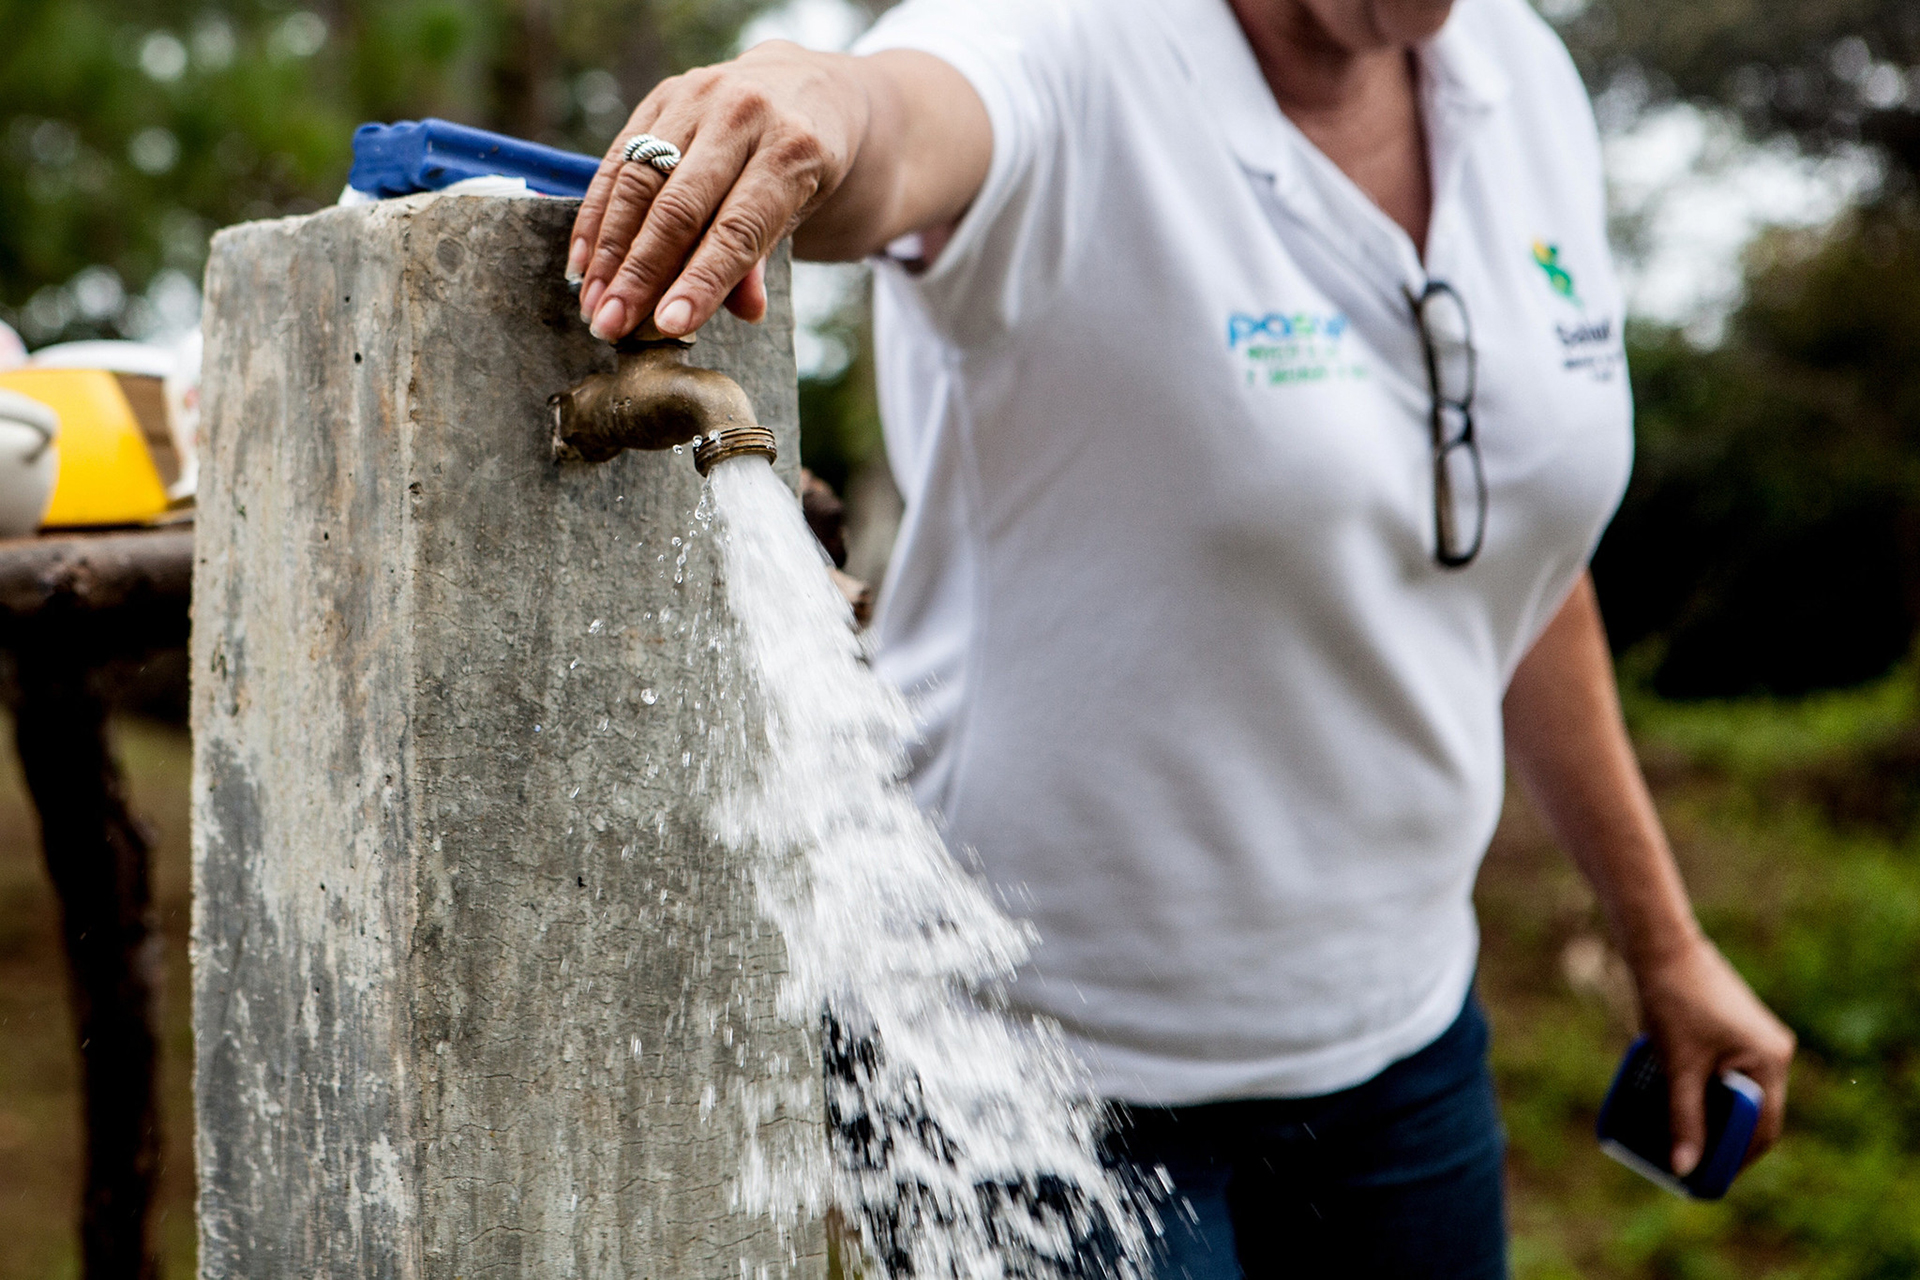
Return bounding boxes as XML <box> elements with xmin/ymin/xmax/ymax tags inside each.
<box><xmin>566</xmin><ymin>40</ymin><xmax>993</xmax><ymax>342</ymax></box>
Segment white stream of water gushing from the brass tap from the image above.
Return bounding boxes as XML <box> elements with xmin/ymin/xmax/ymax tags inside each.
<box><xmin>701</xmin><ymin>457</ymin><xmax>1146</xmax><ymax>1280</ymax></box>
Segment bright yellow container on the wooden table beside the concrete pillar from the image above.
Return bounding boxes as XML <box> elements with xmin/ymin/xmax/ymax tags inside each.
<box><xmin>0</xmin><ymin>368</ymin><xmax>173</xmax><ymax>528</ymax></box>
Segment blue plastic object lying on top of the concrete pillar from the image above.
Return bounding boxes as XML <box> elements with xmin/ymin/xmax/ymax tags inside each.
<box><xmin>348</xmin><ymin>119</ymin><xmax>599</xmax><ymax>198</ymax></box>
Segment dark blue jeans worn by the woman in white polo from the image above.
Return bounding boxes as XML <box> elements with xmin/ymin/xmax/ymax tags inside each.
<box><xmin>1110</xmin><ymin>996</ymin><xmax>1507</xmax><ymax>1280</ymax></box>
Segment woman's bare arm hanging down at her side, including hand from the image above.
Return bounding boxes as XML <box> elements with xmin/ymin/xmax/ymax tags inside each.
<box><xmin>1505</xmin><ymin>574</ymin><xmax>1793</xmax><ymax>1176</ymax></box>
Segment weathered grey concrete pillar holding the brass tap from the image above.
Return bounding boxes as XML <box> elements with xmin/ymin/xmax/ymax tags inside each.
<box><xmin>194</xmin><ymin>198</ymin><xmax>824</xmax><ymax>1280</ymax></box>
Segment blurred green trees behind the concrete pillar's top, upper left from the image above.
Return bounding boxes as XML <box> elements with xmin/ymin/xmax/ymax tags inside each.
<box><xmin>0</xmin><ymin>0</ymin><xmax>770</xmax><ymax>344</ymax></box>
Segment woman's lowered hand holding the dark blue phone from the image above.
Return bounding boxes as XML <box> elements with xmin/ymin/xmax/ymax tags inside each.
<box><xmin>1634</xmin><ymin>936</ymin><xmax>1793</xmax><ymax>1178</ymax></box>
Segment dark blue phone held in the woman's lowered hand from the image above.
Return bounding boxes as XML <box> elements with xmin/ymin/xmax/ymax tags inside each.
<box><xmin>1597</xmin><ymin>1036</ymin><xmax>1763</xmax><ymax>1199</ymax></box>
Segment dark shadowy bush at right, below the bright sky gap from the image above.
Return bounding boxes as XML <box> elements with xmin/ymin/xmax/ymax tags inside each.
<box><xmin>1594</xmin><ymin>200</ymin><xmax>1920</xmax><ymax>697</ymax></box>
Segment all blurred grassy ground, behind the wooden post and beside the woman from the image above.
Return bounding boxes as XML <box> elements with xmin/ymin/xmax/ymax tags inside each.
<box><xmin>0</xmin><ymin>668</ymin><xmax>1920</xmax><ymax>1280</ymax></box>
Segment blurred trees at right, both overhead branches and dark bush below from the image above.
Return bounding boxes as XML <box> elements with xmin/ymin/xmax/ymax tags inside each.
<box><xmin>1540</xmin><ymin>0</ymin><xmax>1920</xmax><ymax>695</ymax></box>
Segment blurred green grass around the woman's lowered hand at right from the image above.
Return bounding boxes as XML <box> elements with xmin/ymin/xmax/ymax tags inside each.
<box><xmin>1478</xmin><ymin>670</ymin><xmax>1920</xmax><ymax>1280</ymax></box>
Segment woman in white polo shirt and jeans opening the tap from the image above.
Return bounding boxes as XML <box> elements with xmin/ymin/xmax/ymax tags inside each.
<box><xmin>570</xmin><ymin>0</ymin><xmax>1793</xmax><ymax>1276</ymax></box>
